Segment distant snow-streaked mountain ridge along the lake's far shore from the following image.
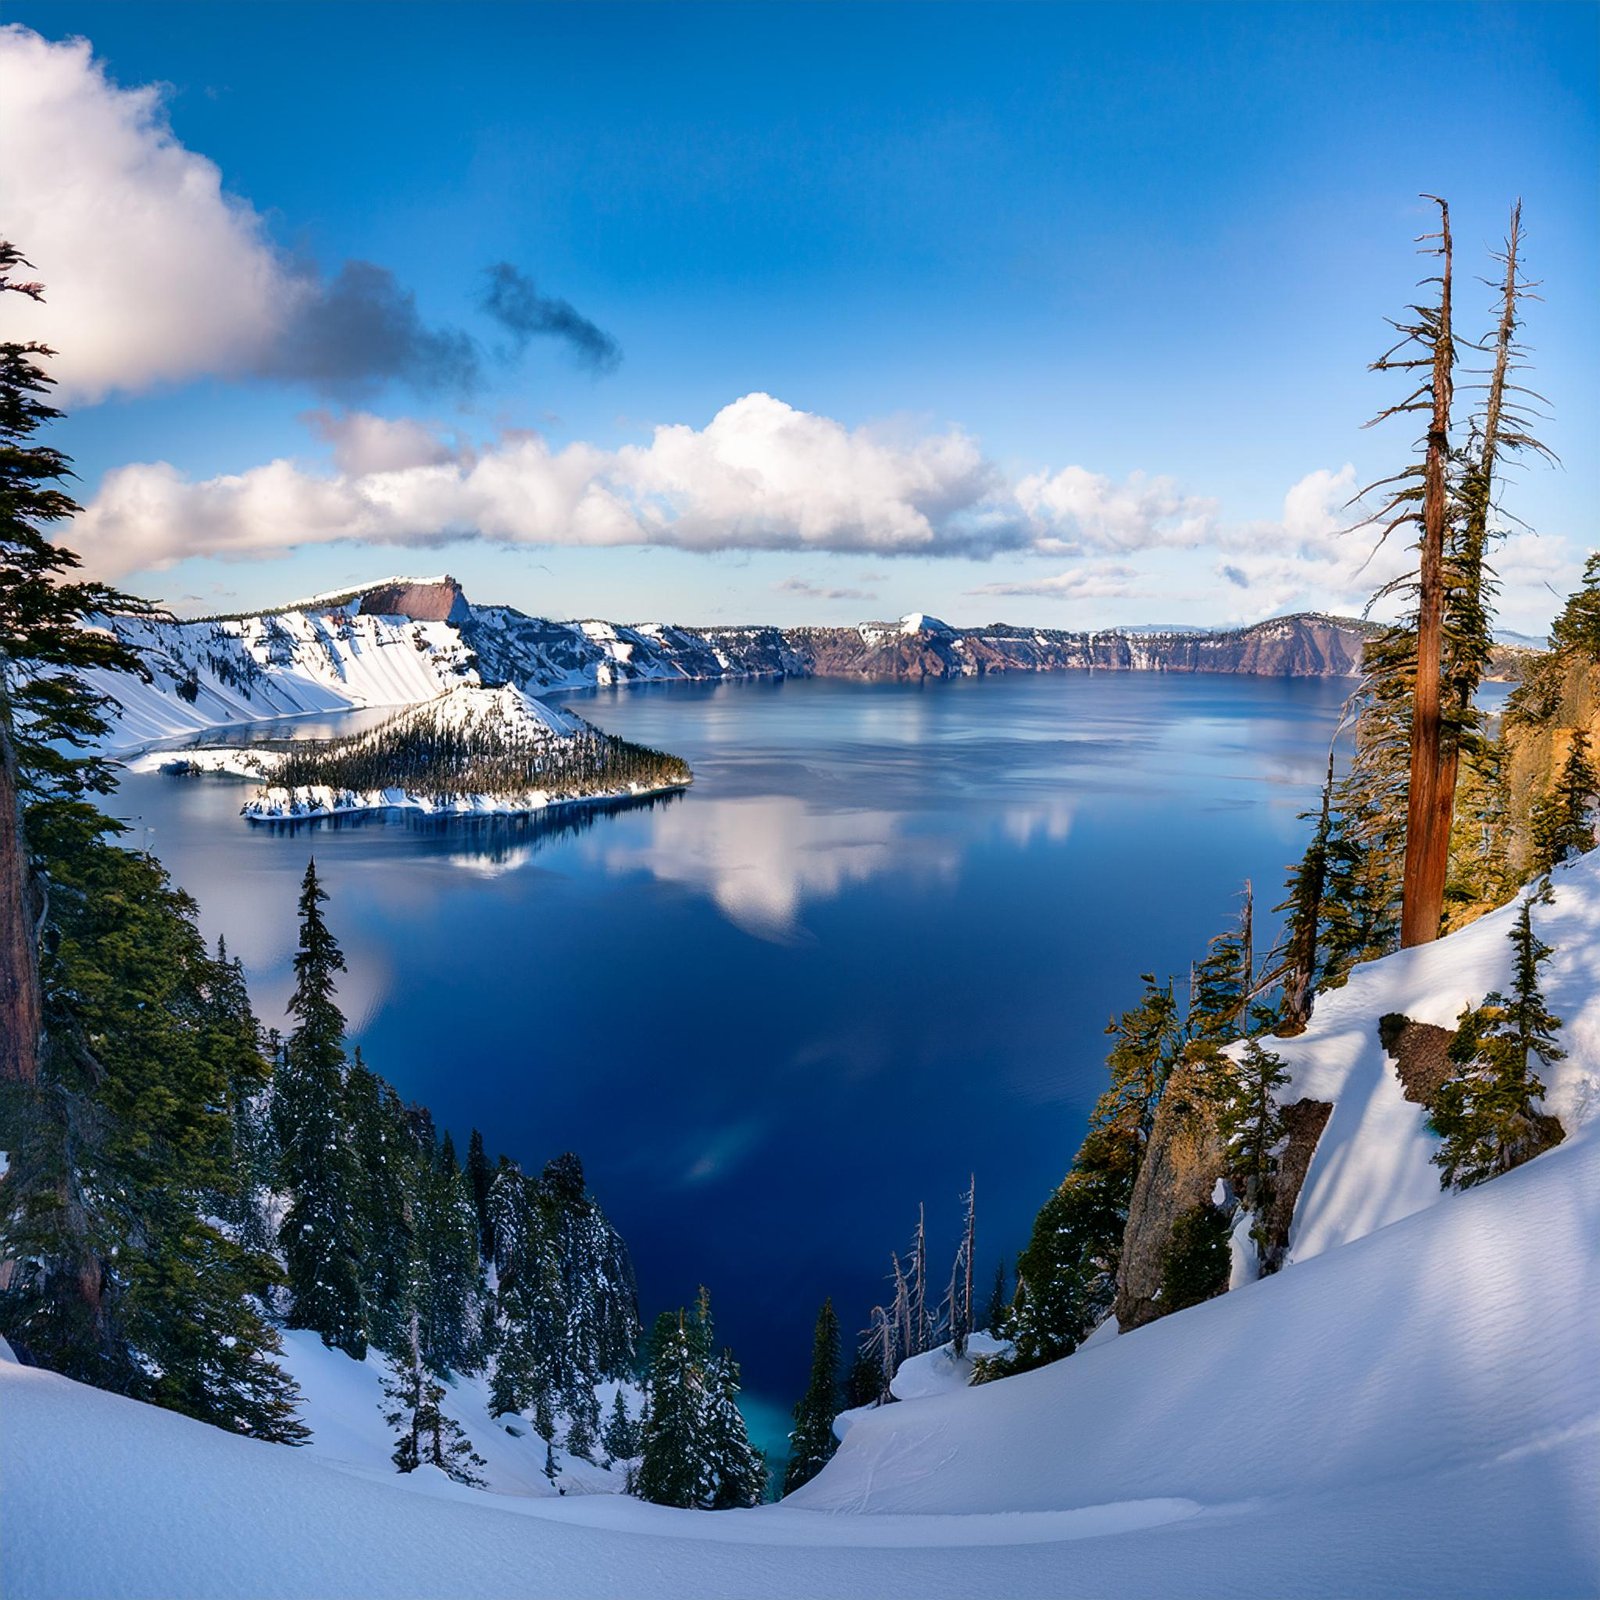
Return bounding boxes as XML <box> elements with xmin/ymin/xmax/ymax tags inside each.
<box><xmin>96</xmin><ymin>574</ymin><xmax>1376</xmax><ymax>746</ymax></box>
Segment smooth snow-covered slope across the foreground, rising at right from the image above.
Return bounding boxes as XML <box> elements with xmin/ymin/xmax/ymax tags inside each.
<box><xmin>0</xmin><ymin>859</ymin><xmax>1600</xmax><ymax>1600</ymax></box>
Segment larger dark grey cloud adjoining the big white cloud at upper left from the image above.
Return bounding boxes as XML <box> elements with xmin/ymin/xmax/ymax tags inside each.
<box><xmin>259</xmin><ymin>261</ymin><xmax>482</xmax><ymax>400</ymax></box>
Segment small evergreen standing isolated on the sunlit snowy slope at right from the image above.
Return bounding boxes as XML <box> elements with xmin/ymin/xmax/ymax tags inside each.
<box><xmin>1429</xmin><ymin>894</ymin><xmax>1565</xmax><ymax>1189</ymax></box>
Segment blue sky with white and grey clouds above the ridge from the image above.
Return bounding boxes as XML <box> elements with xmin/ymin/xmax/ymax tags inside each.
<box><xmin>0</xmin><ymin>0</ymin><xmax>1600</xmax><ymax>632</ymax></box>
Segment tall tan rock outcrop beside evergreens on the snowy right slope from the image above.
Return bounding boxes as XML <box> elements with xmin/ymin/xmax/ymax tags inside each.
<box><xmin>1112</xmin><ymin>1062</ymin><xmax>1226</xmax><ymax>1331</ymax></box>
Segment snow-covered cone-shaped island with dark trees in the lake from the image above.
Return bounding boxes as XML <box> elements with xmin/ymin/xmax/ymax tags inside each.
<box><xmin>130</xmin><ymin>683</ymin><xmax>693</xmax><ymax>822</ymax></box>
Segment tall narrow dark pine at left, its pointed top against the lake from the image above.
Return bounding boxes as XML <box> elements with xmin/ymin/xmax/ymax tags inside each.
<box><xmin>274</xmin><ymin>861</ymin><xmax>366</xmax><ymax>1360</ymax></box>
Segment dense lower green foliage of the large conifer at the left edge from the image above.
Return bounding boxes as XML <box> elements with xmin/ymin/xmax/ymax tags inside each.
<box><xmin>0</xmin><ymin>810</ymin><xmax>304</xmax><ymax>1442</ymax></box>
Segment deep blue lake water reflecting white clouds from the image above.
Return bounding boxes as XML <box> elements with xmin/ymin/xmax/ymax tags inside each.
<box><xmin>112</xmin><ymin>674</ymin><xmax>1349</xmax><ymax>1406</ymax></box>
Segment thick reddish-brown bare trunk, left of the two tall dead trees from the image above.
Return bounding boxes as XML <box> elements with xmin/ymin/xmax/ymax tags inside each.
<box><xmin>1400</xmin><ymin>200</ymin><xmax>1454</xmax><ymax>946</ymax></box>
